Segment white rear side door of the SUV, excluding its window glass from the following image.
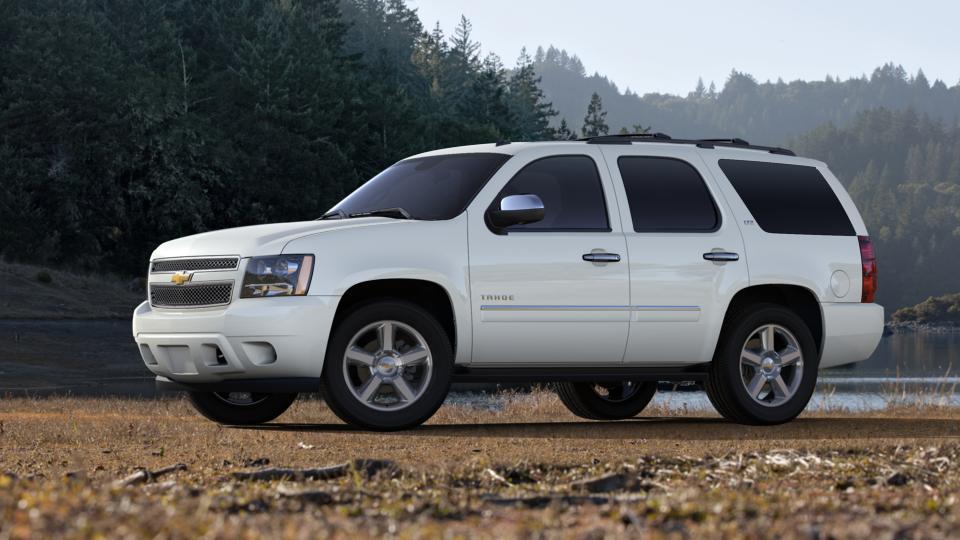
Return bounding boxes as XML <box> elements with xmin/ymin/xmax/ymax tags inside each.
<box><xmin>602</xmin><ymin>143</ymin><xmax>749</xmax><ymax>365</ymax></box>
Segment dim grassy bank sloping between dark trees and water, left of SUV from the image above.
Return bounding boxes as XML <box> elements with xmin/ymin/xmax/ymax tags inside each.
<box><xmin>0</xmin><ymin>261</ymin><xmax>144</xmax><ymax>319</ymax></box>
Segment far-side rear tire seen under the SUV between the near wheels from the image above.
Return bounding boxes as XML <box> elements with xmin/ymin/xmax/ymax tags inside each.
<box><xmin>556</xmin><ymin>381</ymin><xmax>657</xmax><ymax>420</ymax></box>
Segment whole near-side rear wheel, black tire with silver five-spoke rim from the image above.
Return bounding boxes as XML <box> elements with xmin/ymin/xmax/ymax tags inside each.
<box><xmin>704</xmin><ymin>304</ymin><xmax>820</xmax><ymax>425</ymax></box>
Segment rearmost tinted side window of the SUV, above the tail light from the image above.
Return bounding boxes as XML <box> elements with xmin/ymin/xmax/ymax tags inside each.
<box><xmin>720</xmin><ymin>159</ymin><xmax>856</xmax><ymax>236</ymax></box>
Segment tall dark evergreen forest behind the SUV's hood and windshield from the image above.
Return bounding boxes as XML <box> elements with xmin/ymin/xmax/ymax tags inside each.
<box><xmin>0</xmin><ymin>0</ymin><xmax>556</xmax><ymax>274</ymax></box>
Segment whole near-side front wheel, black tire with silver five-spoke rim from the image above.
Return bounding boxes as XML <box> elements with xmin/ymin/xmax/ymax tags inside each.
<box><xmin>321</xmin><ymin>300</ymin><xmax>453</xmax><ymax>431</ymax></box>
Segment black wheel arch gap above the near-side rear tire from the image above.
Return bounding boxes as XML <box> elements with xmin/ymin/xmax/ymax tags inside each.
<box><xmin>715</xmin><ymin>284</ymin><xmax>824</xmax><ymax>355</ymax></box>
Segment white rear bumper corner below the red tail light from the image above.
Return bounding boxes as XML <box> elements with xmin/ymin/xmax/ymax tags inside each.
<box><xmin>820</xmin><ymin>302</ymin><xmax>883</xmax><ymax>369</ymax></box>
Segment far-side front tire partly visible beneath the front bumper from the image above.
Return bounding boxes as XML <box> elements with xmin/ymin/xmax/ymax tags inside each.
<box><xmin>188</xmin><ymin>392</ymin><xmax>297</xmax><ymax>426</ymax></box>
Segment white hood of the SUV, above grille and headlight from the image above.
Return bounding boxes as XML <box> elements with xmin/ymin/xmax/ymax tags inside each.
<box><xmin>150</xmin><ymin>217</ymin><xmax>411</xmax><ymax>260</ymax></box>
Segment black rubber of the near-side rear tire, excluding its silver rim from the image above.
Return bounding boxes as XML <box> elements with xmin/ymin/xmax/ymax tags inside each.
<box><xmin>713</xmin><ymin>304</ymin><xmax>820</xmax><ymax>424</ymax></box>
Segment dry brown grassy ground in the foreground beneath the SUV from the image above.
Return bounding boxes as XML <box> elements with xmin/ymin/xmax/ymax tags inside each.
<box><xmin>0</xmin><ymin>392</ymin><xmax>960</xmax><ymax>538</ymax></box>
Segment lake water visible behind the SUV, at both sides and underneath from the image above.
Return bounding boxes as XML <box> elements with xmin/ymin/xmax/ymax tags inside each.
<box><xmin>0</xmin><ymin>320</ymin><xmax>960</xmax><ymax>411</ymax></box>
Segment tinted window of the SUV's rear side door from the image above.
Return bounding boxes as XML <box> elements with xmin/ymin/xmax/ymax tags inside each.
<box><xmin>617</xmin><ymin>156</ymin><xmax>719</xmax><ymax>232</ymax></box>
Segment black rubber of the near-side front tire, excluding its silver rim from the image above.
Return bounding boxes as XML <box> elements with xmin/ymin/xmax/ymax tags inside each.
<box><xmin>323</xmin><ymin>300</ymin><xmax>453</xmax><ymax>431</ymax></box>
